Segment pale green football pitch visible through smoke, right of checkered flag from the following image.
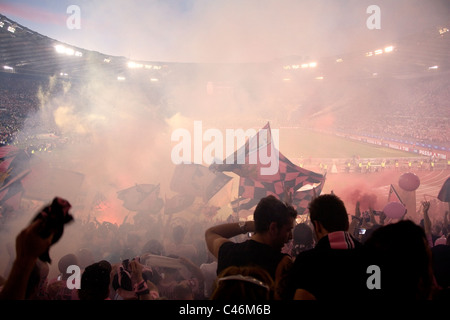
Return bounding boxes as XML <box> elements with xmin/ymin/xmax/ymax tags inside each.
<box><xmin>279</xmin><ymin>128</ymin><xmax>419</xmax><ymax>159</ymax></box>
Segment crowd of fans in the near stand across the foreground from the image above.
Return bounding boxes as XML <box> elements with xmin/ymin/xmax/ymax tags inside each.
<box><xmin>0</xmin><ymin>193</ymin><xmax>450</xmax><ymax>300</ymax></box>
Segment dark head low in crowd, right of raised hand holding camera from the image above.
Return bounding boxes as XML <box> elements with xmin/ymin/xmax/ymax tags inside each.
<box><xmin>78</xmin><ymin>260</ymin><xmax>112</xmax><ymax>300</ymax></box>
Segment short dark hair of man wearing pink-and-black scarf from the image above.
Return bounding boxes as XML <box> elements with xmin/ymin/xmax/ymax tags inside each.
<box><xmin>308</xmin><ymin>194</ymin><xmax>349</xmax><ymax>232</ymax></box>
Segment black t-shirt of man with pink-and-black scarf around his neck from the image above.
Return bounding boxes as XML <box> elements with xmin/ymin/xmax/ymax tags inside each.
<box><xmin>287</xmin><ymin>237</ymin><xmax>368</xmax><ymax>301</ymax></box>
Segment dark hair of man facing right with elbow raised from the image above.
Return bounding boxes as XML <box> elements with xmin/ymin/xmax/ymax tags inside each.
<box><xmin>253</xmin><ymin>195</ymin><xmax>297</xmax><ymax>232</ymax></box>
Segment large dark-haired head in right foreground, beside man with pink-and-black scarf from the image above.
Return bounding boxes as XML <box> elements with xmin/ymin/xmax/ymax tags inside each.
<box><xmin>364</xmin><ymin>220</ymin><xmax>433</xmax><ymax>300</ymax></box>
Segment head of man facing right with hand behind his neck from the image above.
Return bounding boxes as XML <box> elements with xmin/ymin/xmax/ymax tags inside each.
<box><xmin>253</xmin><ymin>195</ymin><xmax>297</xmax><ymax>248</ymax></box>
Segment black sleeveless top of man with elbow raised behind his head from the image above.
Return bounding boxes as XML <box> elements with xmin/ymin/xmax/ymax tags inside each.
<box><xmin>217</xmin><ymin>240</ymin><xmax>285</xmax><ymax>279</ymax></box>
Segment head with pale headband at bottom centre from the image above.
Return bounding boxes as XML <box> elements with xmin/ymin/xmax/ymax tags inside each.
<box><xmin>210</xmin><ymin>266</ymin><xmax>274</xmax><ymax>301</ymax></box>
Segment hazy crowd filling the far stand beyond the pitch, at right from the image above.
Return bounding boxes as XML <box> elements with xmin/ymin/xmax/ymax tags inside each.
<box><xmin>280</xmin><ymin>75</ymin><xmax>450</xmax><ymax>148</ymax></box>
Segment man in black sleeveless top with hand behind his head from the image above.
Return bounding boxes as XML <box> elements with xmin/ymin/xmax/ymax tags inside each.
<box><xmin>205</xmin><ymin>196</ymin><xmax>297</xmax><ymax>300</ymax></box>
